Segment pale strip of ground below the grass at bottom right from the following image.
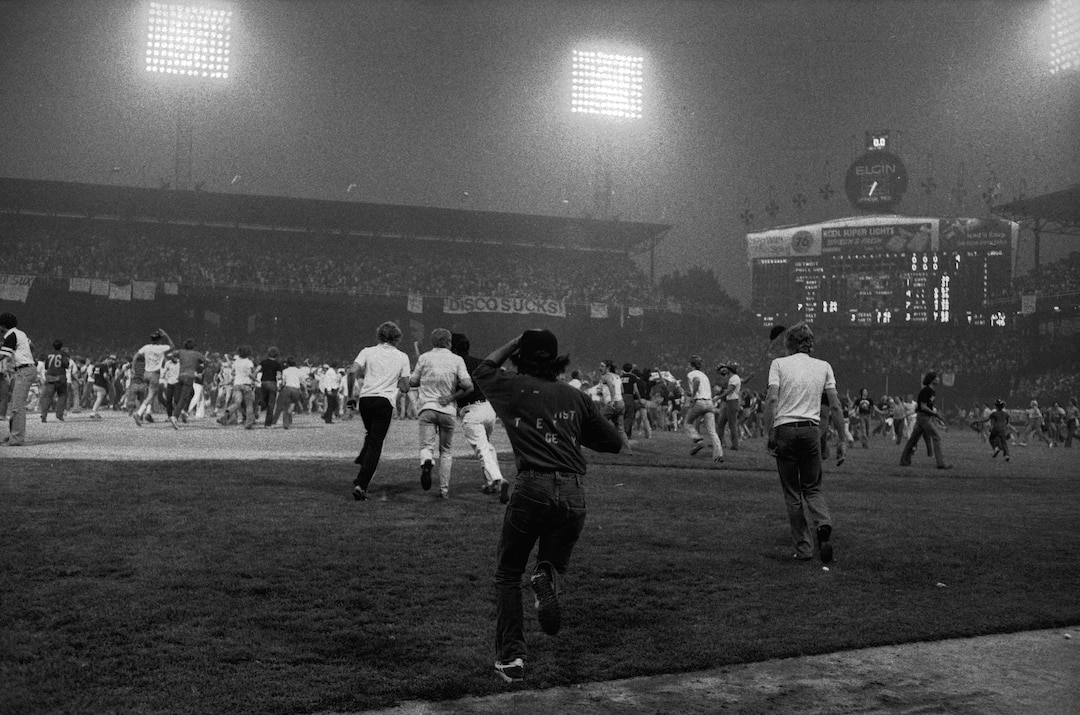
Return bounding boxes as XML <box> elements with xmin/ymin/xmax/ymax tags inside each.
<box><xmin>349</xmin><ymin>626</ymin><xmax>1080</xmax><ymax>715</ymax></box>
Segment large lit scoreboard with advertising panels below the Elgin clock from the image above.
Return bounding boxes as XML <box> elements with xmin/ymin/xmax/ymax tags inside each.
<box><xmin>746</xmin><ymin>215</ymin><xmax>1020</xmax><ymax>325</ymax></box>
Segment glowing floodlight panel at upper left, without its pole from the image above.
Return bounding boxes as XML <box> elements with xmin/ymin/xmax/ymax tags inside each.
<box><xmin>146</xmin><ymin>2</ymin><xmax>232</xmax><ymax>80</ymax></box>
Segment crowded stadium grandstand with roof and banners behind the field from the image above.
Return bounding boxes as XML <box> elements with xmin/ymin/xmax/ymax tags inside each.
<box><xmin>0</xmin><ymin>179</ymin><xmax>1080</xmax><ymax>414</ymax></box>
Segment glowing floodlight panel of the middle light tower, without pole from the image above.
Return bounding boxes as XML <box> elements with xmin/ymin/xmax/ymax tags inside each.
<box><xmin>570</xmin><ymin>50</ymin><xmax>645</xmax><ymax>119</ymax></box>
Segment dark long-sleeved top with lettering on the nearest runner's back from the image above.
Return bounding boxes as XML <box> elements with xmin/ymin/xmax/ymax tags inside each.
<box><xmin>473</xmin><ymin>360</ymin><xmax>622</xmax><ymax>474</ymax></box>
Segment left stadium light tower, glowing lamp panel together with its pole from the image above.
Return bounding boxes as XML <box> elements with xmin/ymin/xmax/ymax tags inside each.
<box><xmin>146</xmin><ymin>2</ymin><xmax>232</xmax><ymax>189</ymax></box>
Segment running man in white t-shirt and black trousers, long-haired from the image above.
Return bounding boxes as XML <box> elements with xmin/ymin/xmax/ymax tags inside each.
<box><xmin>350</xmin><ymin>321</ymin><xmax>409</xmax><ymax>501</ymax></box>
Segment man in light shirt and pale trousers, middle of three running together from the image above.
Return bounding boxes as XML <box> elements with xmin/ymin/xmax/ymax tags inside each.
<box><xmin>408</xmin><ymin>327</ymin><xmax>473</xmax><ymax>499</ymax></box>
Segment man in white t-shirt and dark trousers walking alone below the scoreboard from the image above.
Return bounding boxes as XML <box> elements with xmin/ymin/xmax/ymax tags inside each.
<box><xmin>765</xmin><ymin>323</ymin><xmax>843</xmax><ymax>564</ymax></box>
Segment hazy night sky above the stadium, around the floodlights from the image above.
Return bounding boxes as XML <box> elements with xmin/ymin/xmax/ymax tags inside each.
<box><xmin>0</xmin><ymin>0</ymin><xmax>1080</xmax><ymax>301</ymax></box>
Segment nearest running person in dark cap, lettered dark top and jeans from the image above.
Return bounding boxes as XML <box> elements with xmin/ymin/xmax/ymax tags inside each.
<box><xmin>473</xmin><ymin>330</ymin><xmax>625</xmax><ymax>683</ymax></box>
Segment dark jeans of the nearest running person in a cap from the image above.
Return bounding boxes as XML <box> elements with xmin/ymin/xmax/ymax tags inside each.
<box><xmin>495</xmin><ymin>471</ymin><xmax>585</xmax><ymax>661</ymax></box>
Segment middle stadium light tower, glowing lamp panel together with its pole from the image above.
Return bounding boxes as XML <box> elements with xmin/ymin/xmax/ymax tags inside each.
<box><xmin>570</xmin><ymin>50</ymin><xmax>645</xmax><ymax>218</ymax></box>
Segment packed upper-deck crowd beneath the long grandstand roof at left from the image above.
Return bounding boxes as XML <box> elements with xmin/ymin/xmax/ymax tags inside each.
<box><xmin>4</xmin><ymin>218</ymin><xmax>666</xmax><ymax>308</ymax></box>
